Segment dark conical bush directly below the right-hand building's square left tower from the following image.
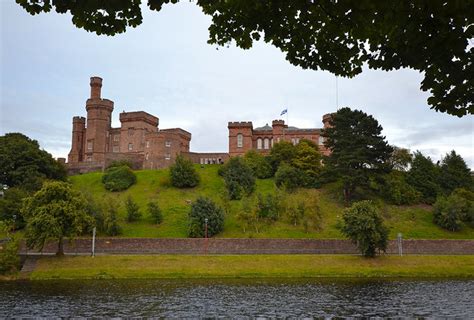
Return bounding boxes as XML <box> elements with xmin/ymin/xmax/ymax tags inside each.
<box><xmin>222</xmin><ymin>157</ymin><xmax>255</xmax><ymax>200</ymax></box>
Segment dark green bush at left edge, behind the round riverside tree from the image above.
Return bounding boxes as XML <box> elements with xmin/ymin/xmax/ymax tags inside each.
<box><xmin>0</xmin><ymin>187</ymin><xmax>28</xmax><ymax>230</ymax></box>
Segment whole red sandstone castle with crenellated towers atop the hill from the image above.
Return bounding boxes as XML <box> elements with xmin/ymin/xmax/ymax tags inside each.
<box><xmin>67</xmin><ymin>77</ymin><xmax>331</xmax><ymax>174</ymax></box>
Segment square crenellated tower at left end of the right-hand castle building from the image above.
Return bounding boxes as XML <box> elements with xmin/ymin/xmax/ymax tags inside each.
<box><xmin>227</xmin><ymin>122</ymin><xmax>253</xmax><ymax>157</ymax></box>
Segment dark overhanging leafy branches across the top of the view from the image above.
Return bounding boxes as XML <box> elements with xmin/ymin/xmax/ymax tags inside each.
<box><xmin>16</xmin><ymin>0</ymin><xmax>474</xmax><ymax>116</ymax></box>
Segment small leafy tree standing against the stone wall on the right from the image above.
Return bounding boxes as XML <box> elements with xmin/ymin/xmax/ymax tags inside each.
<box><xmin>341</xmin><ymin>200</ymin><xmax>389</xmax><ymax>257</ymax></box>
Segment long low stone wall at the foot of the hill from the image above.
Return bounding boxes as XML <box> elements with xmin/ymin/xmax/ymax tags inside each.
<box><xmin>20</xmin><ymin>238</ymin><xmax>474</xmax><ymax>255</ymax></box>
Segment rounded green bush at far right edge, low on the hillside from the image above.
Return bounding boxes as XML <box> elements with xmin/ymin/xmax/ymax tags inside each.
<box><xmin>433</xmin><ymin>189</ymin><xmax>474</xmax><ymax>231</ymax></box>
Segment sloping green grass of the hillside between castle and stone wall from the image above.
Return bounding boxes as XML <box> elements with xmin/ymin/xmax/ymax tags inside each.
<box><xmin>70</xmin><ymin>165</ymin><xmax>474</xmax><ymax>239</ymax></box>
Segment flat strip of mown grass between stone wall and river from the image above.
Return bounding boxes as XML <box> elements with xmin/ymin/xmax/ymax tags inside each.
<box><xmin>30</xmin><ymin>255</ymin><xmax>474</xmax><ymax>280</ymax></box>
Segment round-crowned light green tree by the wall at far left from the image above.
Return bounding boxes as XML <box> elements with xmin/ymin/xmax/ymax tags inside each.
<box><xmin>22</xmin><ymin>181</ymin><xmax>94</xmax><ymax>255</ymax></box>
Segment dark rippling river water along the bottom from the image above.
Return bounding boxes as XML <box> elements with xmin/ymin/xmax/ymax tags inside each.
<box><xmin>0</xmin><ymin>279</ymin><xmax>474</xmax><ymax>319</ymax></box>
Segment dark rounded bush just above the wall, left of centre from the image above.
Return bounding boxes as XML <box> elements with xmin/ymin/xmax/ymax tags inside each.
<box><xmin>188</xmin><ymin>197</ymin><xmax>224</xmax><ymax>238</ymax></box>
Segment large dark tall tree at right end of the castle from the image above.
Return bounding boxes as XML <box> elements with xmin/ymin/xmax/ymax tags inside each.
<box><xmin>322</xmin><ymin>108</ymin><xmax>393</xmax><ymax>202</ymax></box>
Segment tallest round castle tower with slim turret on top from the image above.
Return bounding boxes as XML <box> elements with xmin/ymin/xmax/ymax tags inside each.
<box><xmin>84</xmin><ymin>77</ymin><xmax>114</xmax><ymax>162</ymax></box>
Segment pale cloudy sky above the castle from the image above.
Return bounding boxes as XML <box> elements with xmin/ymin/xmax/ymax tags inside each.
<box><xmin>0</xmin><ymin>0</ymin><xmax>474</xmax><ymax>169</ymax></box>
